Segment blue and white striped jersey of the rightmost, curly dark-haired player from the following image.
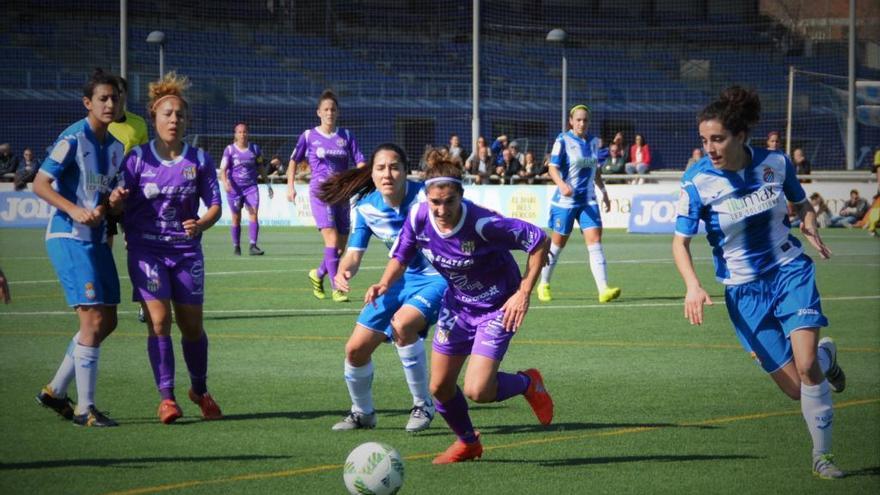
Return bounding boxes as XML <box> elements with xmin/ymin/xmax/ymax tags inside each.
<box><xmin>675</xmin><ymin>147</ymin><xmax>806</xmax><ymax>285</ymax></box>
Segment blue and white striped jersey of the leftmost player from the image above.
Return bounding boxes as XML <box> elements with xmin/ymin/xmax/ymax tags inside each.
<box><xmin>40</xmin><ymin>119</ymin><xmax>125</xmax><ymax>242</ymax></box>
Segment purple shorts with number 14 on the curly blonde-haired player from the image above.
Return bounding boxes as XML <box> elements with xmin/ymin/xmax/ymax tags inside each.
<box><xmin>128</xmin><ymin>250</ymin><xmax>205</xmax><ymax>305</ymax></box>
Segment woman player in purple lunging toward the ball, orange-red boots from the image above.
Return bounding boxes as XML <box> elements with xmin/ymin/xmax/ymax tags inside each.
<box><xmin>364</xmin><ymin>153</ymin><xmax>553</xmax><ymax>464</ymax></box>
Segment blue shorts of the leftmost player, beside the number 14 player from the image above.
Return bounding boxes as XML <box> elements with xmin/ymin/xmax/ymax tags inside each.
<box><xmin>46</xmin><ymin>237</ymin><xmax>119</xmax><ymax>307</ymax></box>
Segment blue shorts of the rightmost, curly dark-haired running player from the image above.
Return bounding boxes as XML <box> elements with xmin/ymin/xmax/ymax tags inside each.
<box><xmin>724</xmin><ymin>254</ymin><xmax>828</xmax><ymax>373</ymax></box>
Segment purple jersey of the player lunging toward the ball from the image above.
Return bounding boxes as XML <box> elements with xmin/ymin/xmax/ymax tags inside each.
<box><xmin>391</xmin><ymin>200</ymin><xmax>547</xmax><ymax>313</ymax></box>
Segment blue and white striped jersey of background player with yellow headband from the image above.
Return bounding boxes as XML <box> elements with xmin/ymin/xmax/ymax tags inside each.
<box><xmin>550</xmin><ymin>130</ymin><xmax>608</xmax><ymax>208</ymax></box>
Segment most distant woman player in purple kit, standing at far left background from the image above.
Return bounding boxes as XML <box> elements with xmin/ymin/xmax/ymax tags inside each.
<box><xmin>220</xmin><ymin>122</ymin><xmax>273</xmax><ymax>256</ymax></box>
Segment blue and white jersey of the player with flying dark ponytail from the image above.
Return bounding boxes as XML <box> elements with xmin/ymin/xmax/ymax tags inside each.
<box><xmin>348</xmin><ymin>180</ymin><xmax>440</xmax><ymax>276</ymax></box>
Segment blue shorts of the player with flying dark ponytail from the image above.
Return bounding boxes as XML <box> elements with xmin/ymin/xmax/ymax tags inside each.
<box><xmin>357</xmin><ymin>273</ymin><xmax>446</xmax><ymax>339</ymax></box>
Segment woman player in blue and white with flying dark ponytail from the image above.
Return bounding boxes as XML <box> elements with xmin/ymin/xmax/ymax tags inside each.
<box><xmin>318</xmin><ymin>144</ymin><xmax>446</xmax><ymax>432</ymax></box>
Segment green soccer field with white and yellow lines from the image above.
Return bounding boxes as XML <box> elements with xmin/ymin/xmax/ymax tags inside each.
<box><xmin>0</xmin><ymin>227</ymin><xmax>880</xmax><ymax>494</ymax></box>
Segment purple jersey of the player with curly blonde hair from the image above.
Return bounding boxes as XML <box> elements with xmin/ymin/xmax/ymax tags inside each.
<box><xmin>122</xmin><ymin>141</ymin><xmax>220</xmax><ymax>252</ymax></box>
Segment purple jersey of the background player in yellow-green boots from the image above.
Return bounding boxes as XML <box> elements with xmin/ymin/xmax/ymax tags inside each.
<box><xmin>290</xmin><ymin>127</ymin><xmax>364</xmax><ymax>185</ymax></box>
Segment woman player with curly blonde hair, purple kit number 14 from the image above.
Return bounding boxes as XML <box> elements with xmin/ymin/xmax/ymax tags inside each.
<box><xmin>122</xmin><ymin>72</ymin><xmax>222</xmax><ymax>424</ymax></box>
